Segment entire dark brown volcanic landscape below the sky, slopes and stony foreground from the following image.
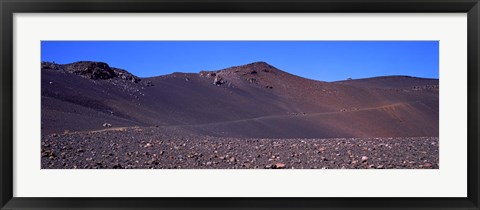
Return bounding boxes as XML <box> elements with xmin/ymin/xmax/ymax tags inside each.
<box><xmin>41</xmin><ymin>62</ymin><xmax>439</xmax><ymax>169</ymax></box>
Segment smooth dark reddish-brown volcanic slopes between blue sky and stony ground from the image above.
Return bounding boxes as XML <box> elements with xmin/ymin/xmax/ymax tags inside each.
<box><xmin>41</xmin><ymin>62</ymin><xmax>439</xmax><ymax>138</ymax></box>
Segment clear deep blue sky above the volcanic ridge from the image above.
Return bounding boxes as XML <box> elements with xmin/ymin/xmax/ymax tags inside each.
<box><xmin>41</xmin><ymin>41</ymin><xmax>439</xmax><ymax>81</ymax></box>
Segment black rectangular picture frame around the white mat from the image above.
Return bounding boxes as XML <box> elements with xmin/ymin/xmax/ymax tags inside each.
<box><xmin>0</xmin><ymin>0</ymin><xmax>480</xmax><ymax>209</ymax></box>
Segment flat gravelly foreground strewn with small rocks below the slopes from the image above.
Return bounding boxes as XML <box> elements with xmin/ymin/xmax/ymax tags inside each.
<box><xmin>41</xmin><ymin>127</ymin><xmax>439</xmax><ymax>169</ymax></box>
